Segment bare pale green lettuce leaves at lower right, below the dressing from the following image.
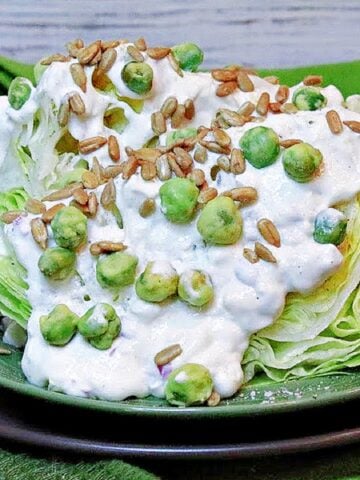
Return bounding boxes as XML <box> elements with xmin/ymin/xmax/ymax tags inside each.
<box><xmin>243</xmin><ymin>199</ymin><xmax>360</xmax><ymax>381</ymax></box>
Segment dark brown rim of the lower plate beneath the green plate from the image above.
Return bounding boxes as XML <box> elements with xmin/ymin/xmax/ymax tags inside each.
<box><xmin>0</xmin><ymin>416</ymin><xmax>360</xmax><ymax>460</ymax></box>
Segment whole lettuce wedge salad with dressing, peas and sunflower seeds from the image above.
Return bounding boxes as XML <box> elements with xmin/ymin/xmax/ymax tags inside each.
<box><xmin>0</xmin><ymin>39</ymin><xmax>360</xmax><ymax>407</ymax></box>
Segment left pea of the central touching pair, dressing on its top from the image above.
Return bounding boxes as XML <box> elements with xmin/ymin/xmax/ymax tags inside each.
<box><xmin>135</xmin><ymin>261</ymin><xmax>179</xmax><ymax>303</ymax></box>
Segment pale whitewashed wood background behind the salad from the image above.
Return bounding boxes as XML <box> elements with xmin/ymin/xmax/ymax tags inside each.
<box><xmin>0</xmin><ymin>0</ymin><xmax>360</xmax><ymax>67</ymax></box>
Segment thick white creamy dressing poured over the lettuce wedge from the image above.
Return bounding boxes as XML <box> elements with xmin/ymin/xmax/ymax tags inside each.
<box><xmin>0</xmin><ymin>45</ymin><xmax>360</xmax><ymax>400</ymax></box>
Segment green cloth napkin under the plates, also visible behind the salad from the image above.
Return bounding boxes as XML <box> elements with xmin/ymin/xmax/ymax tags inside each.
<box><xmin>0</xmin><ymin>56</ymin><xmax>360</xmax><ymax>480</ymax></box>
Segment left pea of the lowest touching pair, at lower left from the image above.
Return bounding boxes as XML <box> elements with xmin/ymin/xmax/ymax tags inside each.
<box><xmin>40</xmin><ymin>305</ymin><xmax>79</xmax><ymax>346</ymax></box>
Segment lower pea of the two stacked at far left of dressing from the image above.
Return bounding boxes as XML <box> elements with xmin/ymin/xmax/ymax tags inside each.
<box><xmin>38</xmin><ymin>247</ymin><xmax>76</xmax><ymax>280</ymax></box>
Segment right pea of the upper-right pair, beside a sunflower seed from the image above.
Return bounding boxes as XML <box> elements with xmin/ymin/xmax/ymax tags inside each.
<box><xmin>282</xmin><ymin>143</ymin><xmax>323</xmax><ymax>183</ymax></box>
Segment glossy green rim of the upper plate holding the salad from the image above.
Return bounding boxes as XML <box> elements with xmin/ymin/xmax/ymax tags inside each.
<box><xmin>0</xmin><ymin>371</ymin><xmax>360</xmax><ymax>419</ymax></box>
